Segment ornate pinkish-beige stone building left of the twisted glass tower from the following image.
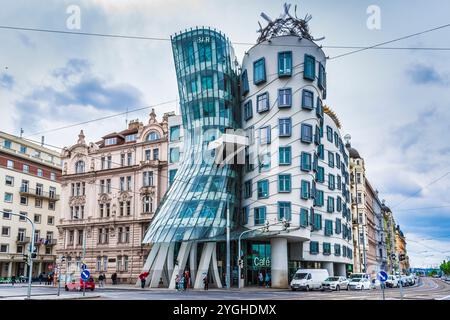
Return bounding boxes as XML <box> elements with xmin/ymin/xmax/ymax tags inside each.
<box><xmin>57</xmin><ymin>110</ymin><xmax>168</xmax><ymax>283</ymax></box>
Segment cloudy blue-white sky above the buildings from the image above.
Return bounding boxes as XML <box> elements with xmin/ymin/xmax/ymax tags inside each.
<box><xmin>0</xmin><ymin>0</ymin><xmax>450</xmax><ymax>266</ymax></box>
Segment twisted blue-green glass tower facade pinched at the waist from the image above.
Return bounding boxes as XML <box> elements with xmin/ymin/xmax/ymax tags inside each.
<box><xmin>144</xmin><ymin>28</ymin><xmax>240</xmax><ymax>243</ymax></box>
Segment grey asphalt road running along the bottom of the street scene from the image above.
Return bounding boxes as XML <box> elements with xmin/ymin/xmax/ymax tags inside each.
<box><xmin>0</xmin><ymin>278</ymin><xmax>450</xmax><ymax>300</ymax></box>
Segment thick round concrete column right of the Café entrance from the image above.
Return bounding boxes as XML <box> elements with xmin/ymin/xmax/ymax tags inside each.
<box><xmin>270</xmin><ymin>238</ymin><xmax>289</xmax><ymax>288</ymax></box>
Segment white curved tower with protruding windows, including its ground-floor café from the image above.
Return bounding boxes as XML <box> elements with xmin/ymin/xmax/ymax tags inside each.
<box><xmin>241</xmin><ymin>35</ymin><xmax>353</xmax><ymax>287</ymax></box>
